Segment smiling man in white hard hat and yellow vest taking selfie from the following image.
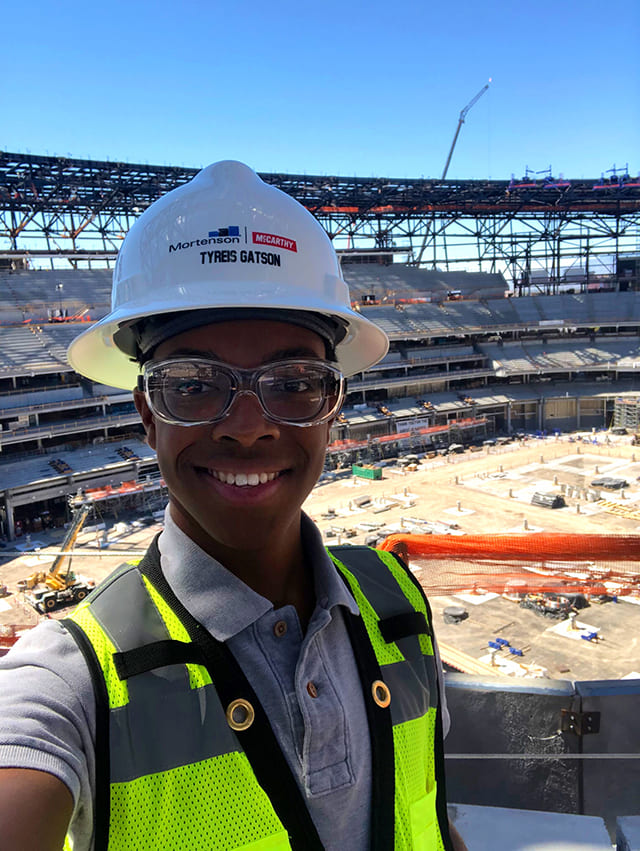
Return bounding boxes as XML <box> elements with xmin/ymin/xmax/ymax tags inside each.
<box><xmin>0</xmin><ymin>162</ymin><xmax>465</xmax><ymax>851</ymax></box>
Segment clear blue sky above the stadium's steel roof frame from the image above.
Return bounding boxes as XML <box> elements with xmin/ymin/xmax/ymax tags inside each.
<box><xmin>0</xmin><ymin>0</ymin><xmax>640</xmax><ymax>179</ymax></box>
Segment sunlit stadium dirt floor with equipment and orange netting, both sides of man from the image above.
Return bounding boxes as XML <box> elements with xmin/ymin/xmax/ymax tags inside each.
<box><xmin>0</xmin><ymin>433</ymin><xmax>640</xmax><ymax>679</ymax></box>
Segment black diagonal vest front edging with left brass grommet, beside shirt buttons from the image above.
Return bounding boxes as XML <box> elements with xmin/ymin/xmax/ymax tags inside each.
<box><xmin>139</xmin><ymin>540</ymin><xmax>322</xmax><ymax>851</ymax></box>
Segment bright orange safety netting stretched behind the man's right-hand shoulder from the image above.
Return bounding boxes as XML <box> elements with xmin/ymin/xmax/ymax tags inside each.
<box><xmin>379</xmin><ymin>532</ymin><xmax>640</xmax><ymax>596</ymax></box>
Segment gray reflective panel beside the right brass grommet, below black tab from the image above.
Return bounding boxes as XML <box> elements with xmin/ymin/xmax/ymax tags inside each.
<box><xmin>380</xmin><ymin>655</ymin><xmax>438</xmax><ymax>725</ymax></box>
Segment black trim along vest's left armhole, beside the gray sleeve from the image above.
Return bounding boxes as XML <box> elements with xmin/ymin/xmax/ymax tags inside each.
<box><xmin>61</xmin><ymin>618</ymin><xmax>111</xmax><ymax>851</ymax></box>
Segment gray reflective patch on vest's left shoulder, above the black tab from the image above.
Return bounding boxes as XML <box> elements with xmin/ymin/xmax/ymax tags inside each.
<box><xmin>91</xmin><ymin>567</ymin><xmax>171</xmax><ymax>651</ymax></box>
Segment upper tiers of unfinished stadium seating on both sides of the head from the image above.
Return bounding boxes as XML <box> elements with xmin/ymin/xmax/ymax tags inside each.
<box><xmin>0</xmin><ymin>264</ymin><xmax>640</xmax><ymax>482</ymax></box>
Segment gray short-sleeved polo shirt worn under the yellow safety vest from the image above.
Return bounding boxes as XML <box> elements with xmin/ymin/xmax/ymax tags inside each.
<box><xmin>0</xmin><ymin>511</ymin><xmax>448</xmax><ymax>851</ymax></box>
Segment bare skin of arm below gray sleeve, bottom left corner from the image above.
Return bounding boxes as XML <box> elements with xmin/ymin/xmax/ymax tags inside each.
<box><xmin>0</xmin><ymin>768</ymin><xmax>73</xmax><ymax>851</ymax></box>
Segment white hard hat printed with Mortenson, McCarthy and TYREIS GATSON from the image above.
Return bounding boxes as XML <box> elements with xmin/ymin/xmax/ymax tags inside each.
<box><xmin>68</xmin><ymin>161</ymin><xmax>389</xmax><ymax>388</ymax></box>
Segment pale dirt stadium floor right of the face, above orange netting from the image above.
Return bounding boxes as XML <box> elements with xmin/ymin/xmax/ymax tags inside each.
<box><xmin>305</xmin><ymin>437</ymin><xmax>640</xmax><ymax>543</ymax></box>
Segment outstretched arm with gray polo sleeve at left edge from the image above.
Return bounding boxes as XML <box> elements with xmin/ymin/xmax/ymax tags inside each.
<box><xmin>0</xmin><ymin>620</ymin><xmax>95</xmax><ymax>851</ymax></box>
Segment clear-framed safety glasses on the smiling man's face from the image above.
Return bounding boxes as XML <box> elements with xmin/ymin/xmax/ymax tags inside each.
<box><xmin>138</xmin><ymin>358</ymin><xmax>344</xmax><ymax>428</ymax></box>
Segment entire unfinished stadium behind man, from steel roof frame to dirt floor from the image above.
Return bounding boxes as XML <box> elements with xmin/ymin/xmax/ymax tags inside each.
<box><xmin>0</xmin><ymin>153</ymin><xmax>640</xmax><ymax>679</ymax></box>
